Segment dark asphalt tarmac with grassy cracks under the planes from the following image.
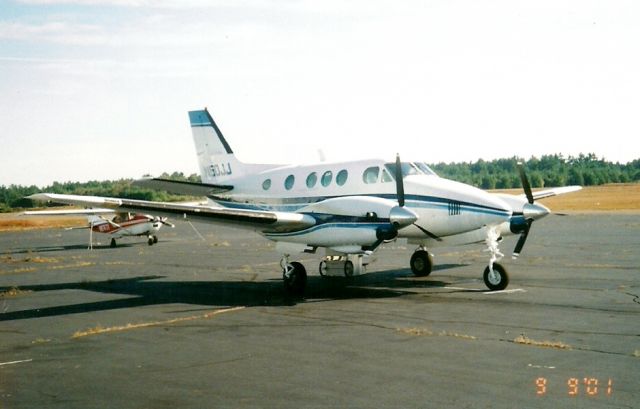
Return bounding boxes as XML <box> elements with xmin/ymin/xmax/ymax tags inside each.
<box><xmin>0</xmin><ymin>214</ymin><xmax>640</xmax><ymax>409</ymax></box>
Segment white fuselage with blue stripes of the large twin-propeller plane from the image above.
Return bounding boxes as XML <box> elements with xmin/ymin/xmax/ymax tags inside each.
<box><xmin>205</xmin><ymin>159</ymin><xmax>512</xmax><ymax>252</ymax></box>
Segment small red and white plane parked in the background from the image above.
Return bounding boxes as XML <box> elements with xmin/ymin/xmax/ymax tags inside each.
<box><xmin>24</xmin><ymin>209</ymin><xmax>174</xmax><ymax>249</ymax></box>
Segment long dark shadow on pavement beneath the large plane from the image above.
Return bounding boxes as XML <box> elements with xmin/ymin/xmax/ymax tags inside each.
<box><xmin>0</xmin><ymin>265</ymin><xmax>470</xmax><ymax>321</ymax></box>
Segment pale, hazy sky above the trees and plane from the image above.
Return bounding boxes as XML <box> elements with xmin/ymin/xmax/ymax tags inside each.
<box><xmin>0</xmin><ymin>0</ymin><xmax>640</xmax><ymax>187</ymax></box>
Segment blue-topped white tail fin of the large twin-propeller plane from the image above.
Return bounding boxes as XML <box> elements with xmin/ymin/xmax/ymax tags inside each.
<box><xmin>189</xmin><ymin>108</ymin><xmax>246</xmax><ymax>184</ymax></box>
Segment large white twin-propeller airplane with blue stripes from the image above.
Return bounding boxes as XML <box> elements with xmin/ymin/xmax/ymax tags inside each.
<box><xmin>30</xmin><ymin>108</ymin><xmax>580</xmax><ymax>295</ymax></box>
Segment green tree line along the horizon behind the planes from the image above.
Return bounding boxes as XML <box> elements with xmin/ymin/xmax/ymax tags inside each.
<box><xmin>0</xmin><ymin>153</ymin><xmax>640</xmax><ymax>212</ymax></box>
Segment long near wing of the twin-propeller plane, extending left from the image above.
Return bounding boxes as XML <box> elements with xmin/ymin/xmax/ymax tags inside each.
<box><xmin>27</xmin><ymin>193</ymin><xmax>316</xmax><ymax>232</ymax></box>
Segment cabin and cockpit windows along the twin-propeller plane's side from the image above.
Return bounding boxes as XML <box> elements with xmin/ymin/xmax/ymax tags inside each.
<box><xmin>262</xmin><ymin>162</ymin><xmax>435</xmax><ymax>190</ymax></box>
